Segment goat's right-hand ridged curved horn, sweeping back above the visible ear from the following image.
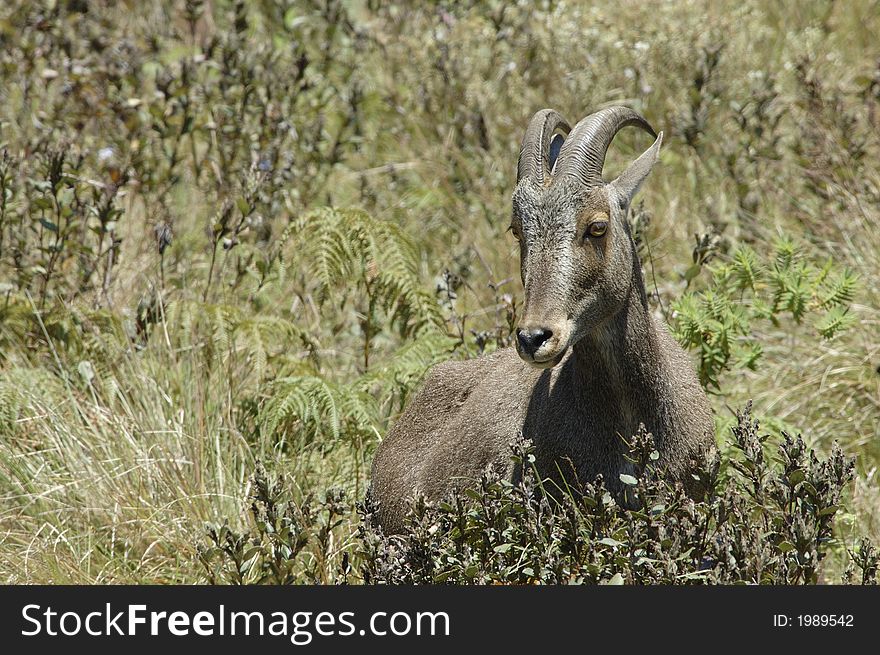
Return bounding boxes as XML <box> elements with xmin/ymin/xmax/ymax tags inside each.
<box><xmin>557</xmin><ymin>106</ymin><xmax>657</xmax><ymax>189</ymax></box>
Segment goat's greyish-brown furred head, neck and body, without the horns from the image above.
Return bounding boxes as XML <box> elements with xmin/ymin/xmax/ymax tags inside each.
<box><xmin>371</xmin><ymin>110</ymin><xmax>714</xmax><ymax>532</ymax></box>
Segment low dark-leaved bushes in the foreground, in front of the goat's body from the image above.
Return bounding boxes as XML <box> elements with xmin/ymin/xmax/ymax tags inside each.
<box><xmin>201</xmin><ymin>405</ymin><xmax>877</xmax><ymax>584</ymax></box>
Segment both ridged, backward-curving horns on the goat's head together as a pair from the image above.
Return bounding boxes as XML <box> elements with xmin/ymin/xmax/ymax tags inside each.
<box><xmin>516</xmin><ymin>106</ymin><xmax>657</xmax><ymax>189</ymax></box>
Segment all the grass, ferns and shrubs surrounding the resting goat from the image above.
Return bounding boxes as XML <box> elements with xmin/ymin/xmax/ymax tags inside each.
<box><xmin>0</xmin><ymin>0</ymin><xmax>880</xmax><ymax>583</ymax></box>
